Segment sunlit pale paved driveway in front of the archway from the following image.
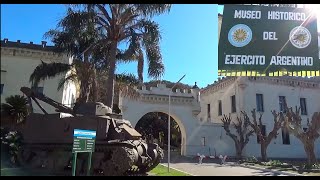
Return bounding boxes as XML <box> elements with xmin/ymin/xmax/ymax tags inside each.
<box><xmin>163</xmin><ymin>162</ymin><xmax>285</xmax><ymax>176</ymax></box>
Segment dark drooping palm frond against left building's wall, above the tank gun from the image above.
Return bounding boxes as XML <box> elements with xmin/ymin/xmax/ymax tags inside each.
<box><xmin>29</xmin><ymin>61</ymin><xmax>72</xmax><ymax>87</ymax></box>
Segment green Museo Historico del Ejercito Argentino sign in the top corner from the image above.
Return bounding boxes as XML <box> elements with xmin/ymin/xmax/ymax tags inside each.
<box><xmin>218</xmin><ymin>4</ymin><xmax>320</xmax><ymax>76</ymax></box>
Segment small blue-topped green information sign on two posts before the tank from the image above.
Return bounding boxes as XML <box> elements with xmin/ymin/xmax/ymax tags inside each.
<box><xmin>72</xmin><ymin>129</ymin><xmax>96</xmax><ymax>176</ymax></box>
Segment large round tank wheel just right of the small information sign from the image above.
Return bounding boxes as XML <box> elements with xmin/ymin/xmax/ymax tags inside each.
<box><xmin>101</xmin><ymin>147</ymin><xmax>134</xmax><ymax>176</ymax></box>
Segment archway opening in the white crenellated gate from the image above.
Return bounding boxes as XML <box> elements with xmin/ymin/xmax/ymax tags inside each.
<box><xmin>135</xmin><ymin>111</ymin><xmax>186</xmax><ymax>155</ymax></box>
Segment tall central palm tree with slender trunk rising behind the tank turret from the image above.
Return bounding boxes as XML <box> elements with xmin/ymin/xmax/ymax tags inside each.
<box><xmin>60</xmin><ymin>4</ymin><xmax>171</xmax><ymax>107</ymax></box>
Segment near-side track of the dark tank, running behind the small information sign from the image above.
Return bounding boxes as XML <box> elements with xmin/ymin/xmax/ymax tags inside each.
<box><xmin>20</xmin><ymin>143</ymin><xmax>163</xmax><ymax>176</ymax></box>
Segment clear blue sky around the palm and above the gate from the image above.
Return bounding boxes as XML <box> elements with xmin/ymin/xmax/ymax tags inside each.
<box><xmin>1</xmin><ymin>4</ymin><xmax>223</xmax><ymax>87</ymax></box>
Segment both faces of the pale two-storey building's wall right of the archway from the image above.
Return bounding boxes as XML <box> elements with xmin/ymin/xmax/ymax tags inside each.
<box><xmin>198</xmin><ymin>77</ymin><xmax>320</xmax><ymax>158</ymax></box>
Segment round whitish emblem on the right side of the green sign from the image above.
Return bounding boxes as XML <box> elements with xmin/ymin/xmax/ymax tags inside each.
<box><xmin>289</xmin><ymin>26</ymin><xmax>311</xmax><ymax>49</ymax></box>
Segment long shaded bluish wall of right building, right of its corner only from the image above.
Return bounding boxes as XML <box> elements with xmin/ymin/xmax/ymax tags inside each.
<box><xmin>245</xmin><ymin>78</ymin><xmax>320</xmax><ymax>158</ymax></box>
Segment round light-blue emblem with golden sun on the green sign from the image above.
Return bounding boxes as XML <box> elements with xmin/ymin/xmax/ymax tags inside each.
<box><xmin>228</xmin><ymin>24</ymin><xmax>252</xmax><ymax>47</ymax></box>
